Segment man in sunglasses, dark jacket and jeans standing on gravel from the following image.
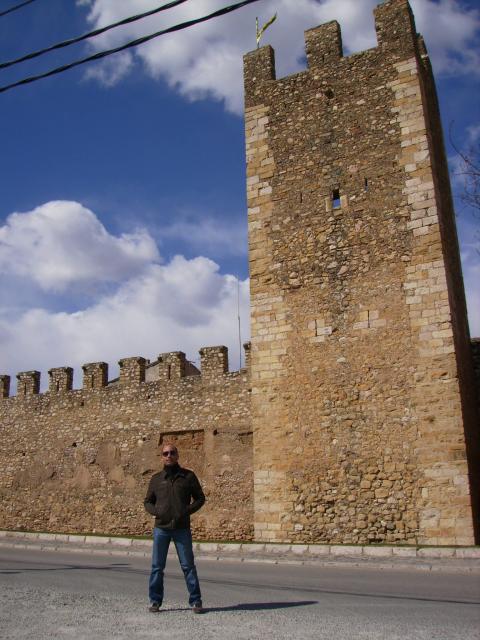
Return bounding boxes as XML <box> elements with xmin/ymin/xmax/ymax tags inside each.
<box><xmin>144</xmin><ymin>444</ymin><xmax>205</xmax><ymax>613</ymax></box>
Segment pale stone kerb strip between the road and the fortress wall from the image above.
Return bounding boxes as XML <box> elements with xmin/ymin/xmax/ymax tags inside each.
<box><xmin>0</xmin><ymin>531</ymin><xmax>480</xmax><ymax>574</ymax></box>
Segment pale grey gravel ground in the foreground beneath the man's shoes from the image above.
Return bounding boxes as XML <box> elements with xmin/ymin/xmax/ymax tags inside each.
<box><xmin>0</xmin><ymin>588</ymin><xmax>480</xmax><ymax>640</ymax></box>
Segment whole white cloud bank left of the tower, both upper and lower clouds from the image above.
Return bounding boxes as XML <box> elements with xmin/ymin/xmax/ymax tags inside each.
<box><xmin>0</xmin><ymin>202</ymin><xmax>249</xmax><ymax>387</ymax></box>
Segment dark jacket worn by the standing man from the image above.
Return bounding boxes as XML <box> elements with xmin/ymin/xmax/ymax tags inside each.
<box><xmin>143</xmin><ymin>465</ymin><xmax>205</xmax><ymax>529</ymax></box>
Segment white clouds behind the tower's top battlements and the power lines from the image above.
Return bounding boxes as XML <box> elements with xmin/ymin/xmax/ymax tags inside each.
<box><xmin>79</xmin><ymin>0</ymin><xmax>480</xmax><ymax>113</ymax></box>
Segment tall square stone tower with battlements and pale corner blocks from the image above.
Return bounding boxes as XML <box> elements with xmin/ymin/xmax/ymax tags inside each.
<box><xmin>244</xmin><ymin>0</ymin><xmax>478</xmax><ymax>544</ymax></box>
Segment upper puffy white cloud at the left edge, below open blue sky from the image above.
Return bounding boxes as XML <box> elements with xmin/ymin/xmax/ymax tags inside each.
<box><xmin>0</xmin><ymin>201</ymin><xmax>159</xmax><ymax>291</ymax></box>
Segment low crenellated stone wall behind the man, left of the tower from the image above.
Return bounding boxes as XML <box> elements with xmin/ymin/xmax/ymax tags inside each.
<box><xmin>0</xmin><ymin>347</ymin><xmax>253</xmax><ymax>540</ymax></box>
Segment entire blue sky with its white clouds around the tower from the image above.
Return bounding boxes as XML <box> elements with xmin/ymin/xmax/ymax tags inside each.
<box><xmin>0</xmin><ymin>0</ymin><xmax>480</xmax><ymax>386</ymax></box>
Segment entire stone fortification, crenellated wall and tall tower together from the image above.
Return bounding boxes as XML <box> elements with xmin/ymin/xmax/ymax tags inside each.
<box><xmin>0</xmin><ymin>0</ymin><xmax>480</xmax><ymax>545</ymax></box>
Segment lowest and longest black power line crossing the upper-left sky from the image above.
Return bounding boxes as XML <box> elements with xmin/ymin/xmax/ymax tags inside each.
<box><xmin>0</xmin><ymin>0</ymin><xmax>259</xmax><ymax>93</ymax></box>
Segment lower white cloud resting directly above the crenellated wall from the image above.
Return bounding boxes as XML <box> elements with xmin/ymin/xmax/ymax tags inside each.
<box><xmin>0</xmin><ymin>256</ymin><xmax>249</xmax><ymax>386</ymax></box>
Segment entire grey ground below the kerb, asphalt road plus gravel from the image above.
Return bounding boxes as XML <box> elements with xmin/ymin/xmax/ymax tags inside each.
<box><xmin>0</xmin><ymin>549</ymin><xmax>480</xmax><ymax>640</ymax></box>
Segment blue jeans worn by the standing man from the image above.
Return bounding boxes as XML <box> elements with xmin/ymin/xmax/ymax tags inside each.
<box><xmin>148</xmin><ymin>527</ymin><xmax>202</xmax><ymax>606</ymax></box>
